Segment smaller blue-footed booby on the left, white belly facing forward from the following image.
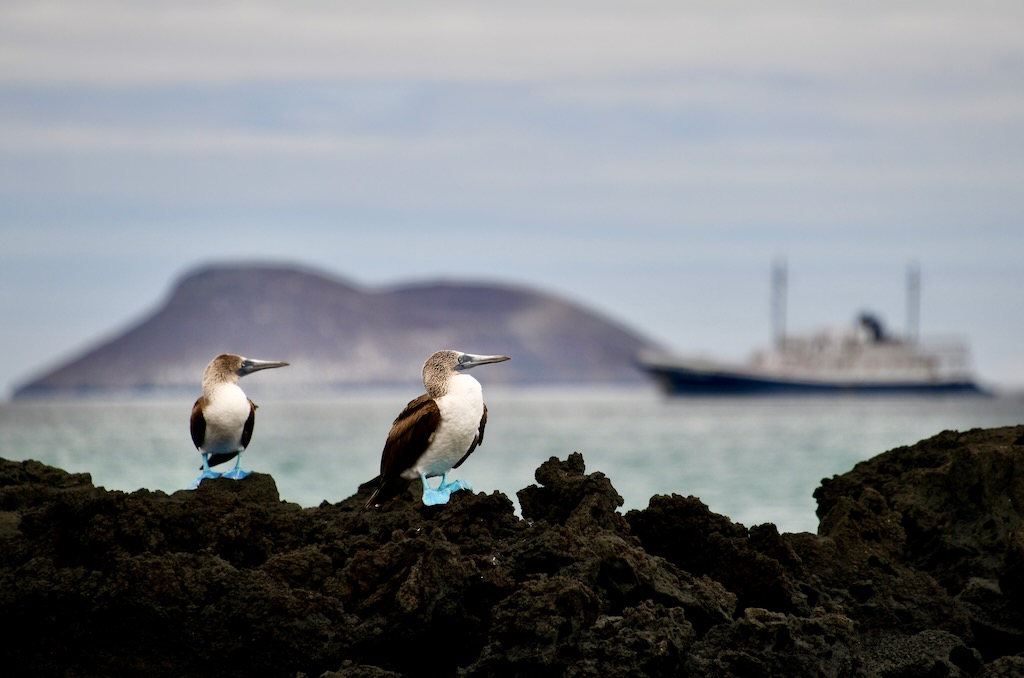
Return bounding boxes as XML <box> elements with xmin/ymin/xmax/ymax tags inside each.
<box><xmin>189</xmin><ymin>353</ymin><xmax>288</xmax><ymax>489</ymax></box>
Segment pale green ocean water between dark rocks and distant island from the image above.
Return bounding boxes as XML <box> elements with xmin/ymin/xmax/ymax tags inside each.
<box><xmin>0</xmin><ymin>384</ymin><xmax>1024</xmax><ymax>532</ymax></box>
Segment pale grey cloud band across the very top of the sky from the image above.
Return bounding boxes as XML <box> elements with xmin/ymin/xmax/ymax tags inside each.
<box><xmin>0</xmin><ymin>0</ymin><xmax>1024</xmax><ymax>84</ymax></box>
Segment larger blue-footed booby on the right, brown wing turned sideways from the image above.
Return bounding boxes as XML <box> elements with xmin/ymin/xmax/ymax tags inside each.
<box><xmin>359</xmin><ymin>350</ymin><xmax>509</xmax><ymax>508</ymax></box>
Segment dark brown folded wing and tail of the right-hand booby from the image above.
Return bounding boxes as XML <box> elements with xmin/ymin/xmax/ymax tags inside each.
<box><xmin>360</xmin><ymin>393</ymin><xmax>441</xmax><ymax>508</ymax></box>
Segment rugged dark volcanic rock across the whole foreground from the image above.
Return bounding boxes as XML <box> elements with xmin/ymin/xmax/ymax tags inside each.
<box><xmin>6</xmin><ymin>427</ymin><xmax>1024</xmax><ymax>678</ymax></box>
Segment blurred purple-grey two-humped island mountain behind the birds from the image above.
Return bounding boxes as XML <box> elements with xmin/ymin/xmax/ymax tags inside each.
<box><xmin>14</xmin><ymin>264</ymin><xmax>651</xmax><ymax>397</ymax></box>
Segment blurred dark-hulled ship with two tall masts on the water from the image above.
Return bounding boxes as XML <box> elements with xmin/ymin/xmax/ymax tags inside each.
<box><xmin>637</xmin><ymin>266</ymin><xmax>984</xmax><ymax>395</ymax></box>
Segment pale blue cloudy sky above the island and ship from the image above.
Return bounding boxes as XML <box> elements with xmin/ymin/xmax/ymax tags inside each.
<box><xmin>0</xmin><ymin>0</ymin><xmax>1024</xmax><ymax>398</ymax></box>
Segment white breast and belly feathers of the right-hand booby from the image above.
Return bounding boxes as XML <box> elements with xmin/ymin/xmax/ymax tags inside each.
<box><xmin>413</xmin><ymin>374</ymin><xmax>483</xmax><ymax>477</ymax></box>
